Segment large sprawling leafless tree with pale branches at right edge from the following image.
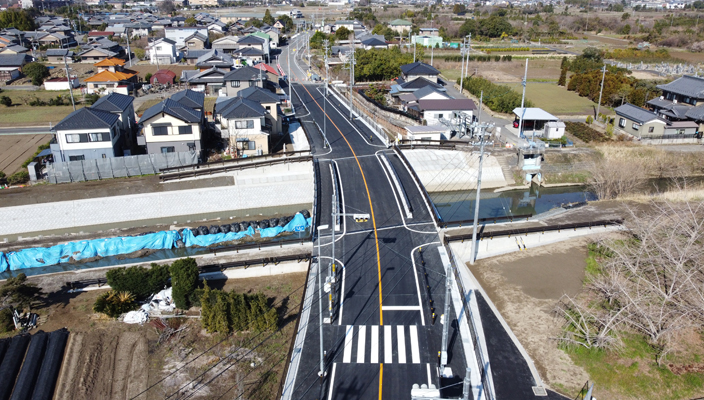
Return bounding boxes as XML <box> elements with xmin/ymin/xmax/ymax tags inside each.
<box><xmin>556</xmin><ymin>202</ymin><xmax>704</xmax><ymax>363</ymax></box>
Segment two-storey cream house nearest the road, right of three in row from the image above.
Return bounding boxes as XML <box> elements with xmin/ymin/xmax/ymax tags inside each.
<box><xmin>215</xmin><ymin>97</ymin><xmax>271</xmax><ymax>156</ymax></box>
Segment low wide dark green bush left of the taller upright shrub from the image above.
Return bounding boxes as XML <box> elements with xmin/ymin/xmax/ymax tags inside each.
<box><xmin>106</xmin><ymin>263</ymin><xmax>171</xmax><ymax>300</ymax></box>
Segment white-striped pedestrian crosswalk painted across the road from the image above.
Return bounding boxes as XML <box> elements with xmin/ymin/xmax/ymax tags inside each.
<box><xmin>342</xmin><ymin>325</ymin><xmax>421</xmax><ymax>364</ymax></box>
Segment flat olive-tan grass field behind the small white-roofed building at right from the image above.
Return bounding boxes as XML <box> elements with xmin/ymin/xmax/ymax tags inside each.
<box><xmin>506</xmin><ymin>82</ymin><xmax>605</xmax><ymax>115</ymax></box>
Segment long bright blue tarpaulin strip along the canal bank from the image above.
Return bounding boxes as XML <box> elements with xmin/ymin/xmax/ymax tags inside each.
<box><xmin>0</xmin><ymin>213</ymin><xmax>312</xmax><ymax>273</ymax></box>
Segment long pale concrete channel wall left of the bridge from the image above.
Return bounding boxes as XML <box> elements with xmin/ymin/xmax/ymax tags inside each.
<box><xmin>0</xmin><ymin>162</ymin><xmax>313</xmax><ymax>241</ymax></box>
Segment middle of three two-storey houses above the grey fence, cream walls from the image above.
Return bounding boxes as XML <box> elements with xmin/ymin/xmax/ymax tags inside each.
<box><xmin>137</xmin><ymin>90</ymin><xmax>205</xmax><ymax>154</ymax></box>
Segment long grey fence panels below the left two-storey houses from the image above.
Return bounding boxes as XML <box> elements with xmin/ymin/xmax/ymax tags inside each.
<box><xmin>46</xmin><ymin>152</ymin><xmax>198</xmax><ymax>183</ymax></box>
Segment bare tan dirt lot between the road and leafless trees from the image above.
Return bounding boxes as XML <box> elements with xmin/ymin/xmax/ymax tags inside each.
<box><xmin>470</xmin><ymin>238</ymin><xmax>589</xmax><ymax>396</ymax></box>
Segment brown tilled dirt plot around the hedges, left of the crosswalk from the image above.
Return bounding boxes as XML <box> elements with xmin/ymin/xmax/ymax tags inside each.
<box><xmin>30</xmin><ymin>273</ymin><xmax>306</xmax><ymax>399</ymax></box>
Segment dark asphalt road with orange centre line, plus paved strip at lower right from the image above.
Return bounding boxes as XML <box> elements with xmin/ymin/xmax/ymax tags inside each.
<box><xmin>280</xmin><ymin>32</ymin><xmax>572</xmax><ymax>399</ymax></box>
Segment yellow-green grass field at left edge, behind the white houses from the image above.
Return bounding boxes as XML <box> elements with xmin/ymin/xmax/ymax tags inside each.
<box><xmin>0</xmin><ymin>90</ymin><xmax>83</xmax><ymax>127</ymax></box>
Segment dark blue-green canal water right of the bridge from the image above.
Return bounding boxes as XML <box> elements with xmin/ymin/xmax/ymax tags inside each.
<box><xmin>429</xmin><ymin>184</ymin><xmax>596</xmax><ymax>223</ymax></box>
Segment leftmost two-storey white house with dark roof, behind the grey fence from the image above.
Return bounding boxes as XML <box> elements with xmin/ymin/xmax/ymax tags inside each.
<box><xmin>50</xmin><ymin>107</ymin><xmax>123</xmax><ymax>163</ymax></box>
